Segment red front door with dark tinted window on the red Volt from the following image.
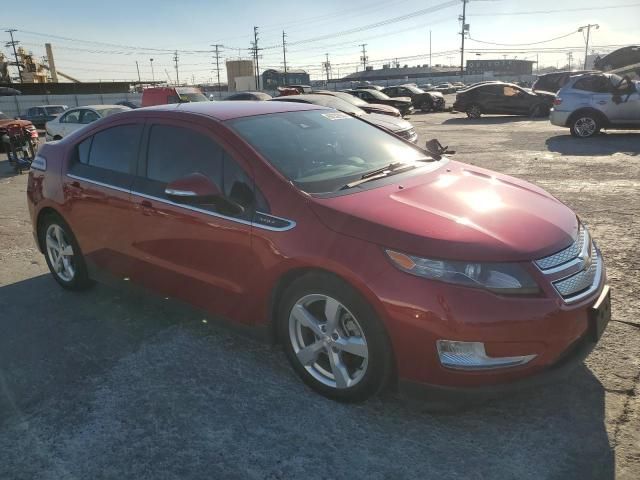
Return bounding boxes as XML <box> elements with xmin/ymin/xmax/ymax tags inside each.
<box><xmin>132</xmin><ymin>120</ymin><xmax>255</xmax><ymax>315</ymax></box>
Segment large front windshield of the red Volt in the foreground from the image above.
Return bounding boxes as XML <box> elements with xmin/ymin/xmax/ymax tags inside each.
<box><xmin>230</xmin><ymin>110</ymin><xmax>428</xmax><ymax>193</ymax></box>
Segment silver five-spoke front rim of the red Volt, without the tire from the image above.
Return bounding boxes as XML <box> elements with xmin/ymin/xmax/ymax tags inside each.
<box><xmin>289</xmin><ymin>294</ymin><xmax>369</xmax><ymax>389</ymax></box>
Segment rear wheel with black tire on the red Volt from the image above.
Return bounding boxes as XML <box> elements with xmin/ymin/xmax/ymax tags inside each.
<box><xmin>38</xmin><ymin>214</ymin><xmax>92</xmax><ymax>290</ymax></box>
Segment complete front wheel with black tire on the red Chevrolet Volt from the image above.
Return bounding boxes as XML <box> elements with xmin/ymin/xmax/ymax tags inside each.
<box><xmin>276</xmin><ymin>274</ymin><xmax>393</xmax><ymax>402</ymax></box>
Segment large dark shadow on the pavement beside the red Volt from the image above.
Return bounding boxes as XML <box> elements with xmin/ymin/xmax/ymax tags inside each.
<box><xmin>0</xmin><ymin>275</ymin><xmax>615</xmax><ymax>480</ymax></box>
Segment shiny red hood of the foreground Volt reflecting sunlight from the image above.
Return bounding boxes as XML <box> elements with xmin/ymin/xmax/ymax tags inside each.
<box><xmin>311</xmin><ymin>160</ymin><xmax>578</xmax><ymax>262</ymax></box>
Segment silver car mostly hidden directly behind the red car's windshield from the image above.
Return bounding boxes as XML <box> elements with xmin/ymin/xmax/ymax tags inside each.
<box><xmin>271</xmin><ymin>93</ymin><xmax>418</xmax><ymax>143</ymax></box>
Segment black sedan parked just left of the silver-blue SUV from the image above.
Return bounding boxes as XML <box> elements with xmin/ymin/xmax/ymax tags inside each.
<box><xmin>453</xmin><ymin>83</ymin><xmax>555</xmax><ymax>118</ymax></box>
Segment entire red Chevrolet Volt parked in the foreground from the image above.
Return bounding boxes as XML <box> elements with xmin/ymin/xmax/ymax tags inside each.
<box><xmin>27</xmin><ymin>102</ymin><xmax>610</xmax><ymax>401</ymax></box>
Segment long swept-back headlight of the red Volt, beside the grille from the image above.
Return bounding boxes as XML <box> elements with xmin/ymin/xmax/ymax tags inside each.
<box><xmin>385</xmin><ymin>250</ymin><xmax>539</xmax><ymax>295</ymax></box>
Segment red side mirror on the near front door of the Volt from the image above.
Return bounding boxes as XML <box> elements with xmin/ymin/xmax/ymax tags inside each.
<box><xmin>164</xmin><ymin>173</ymin><xmax>244</xmax><ymax>215</ymax></box>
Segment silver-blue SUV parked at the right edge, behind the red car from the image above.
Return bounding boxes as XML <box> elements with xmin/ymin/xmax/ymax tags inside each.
<box><xmin>550</xmin><ymin>73</ymin><xmax>640</xmax><ymax>138</ymax></box>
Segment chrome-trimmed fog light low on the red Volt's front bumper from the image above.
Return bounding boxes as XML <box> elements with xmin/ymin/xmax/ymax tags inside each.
<box><xmin>436</xmin><ymin>340</ymin><xmax>536</xmax><ymax>370</ymax></box>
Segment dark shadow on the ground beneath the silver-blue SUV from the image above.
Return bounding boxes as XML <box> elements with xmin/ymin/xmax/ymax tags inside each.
<box><xmin>545</xmin><ymin>130</ymin><xmax>640</xmax><ymax>156</ymax></box>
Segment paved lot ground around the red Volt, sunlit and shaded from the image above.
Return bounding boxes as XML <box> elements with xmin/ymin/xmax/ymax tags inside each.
<box><xmin>0</xmin><ymin>111</ymin><xmax>640</xmax><ymax>479</ymax></box>
